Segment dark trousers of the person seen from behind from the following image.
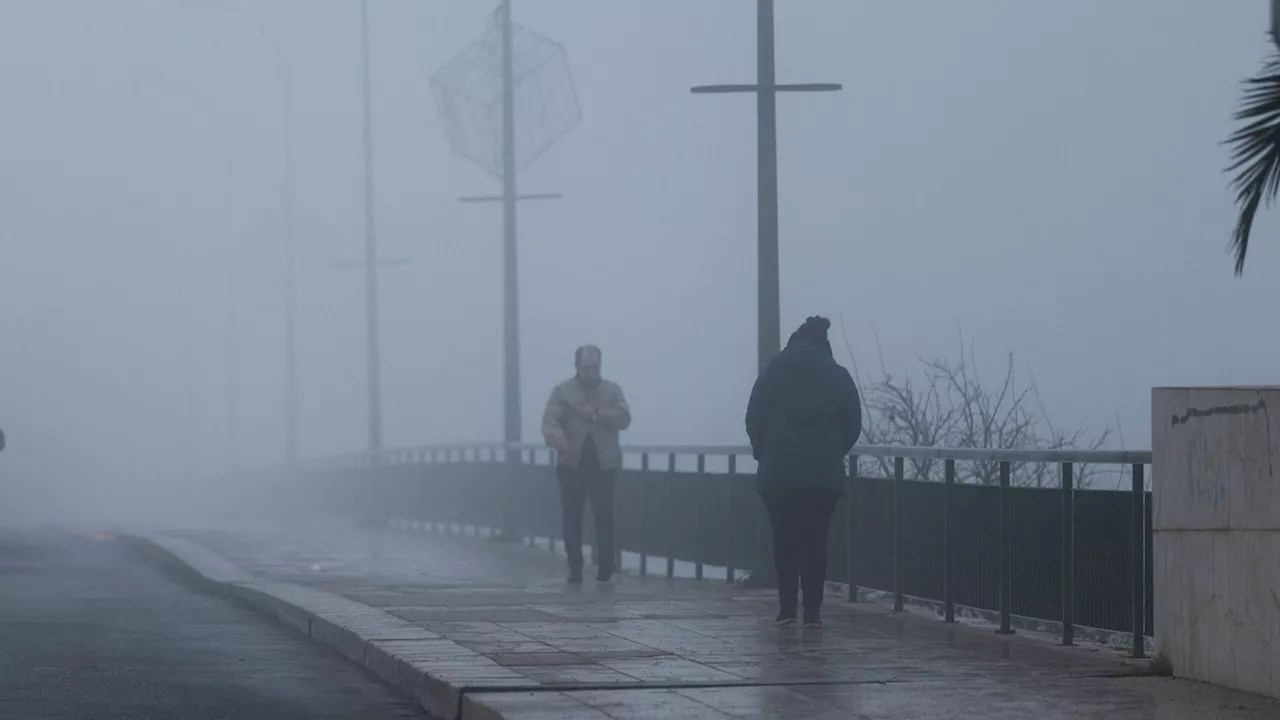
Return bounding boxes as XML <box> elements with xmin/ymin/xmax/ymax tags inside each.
<box><xmin>762</xmin><ymin>491</ymin><xmax>840</xmax><ymax>614</ymax></box>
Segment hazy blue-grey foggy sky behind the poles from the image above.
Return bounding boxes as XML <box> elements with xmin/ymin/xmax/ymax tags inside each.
<box><xmin>0</xmin><ymin>0</ymin><xmax>1280</xmax><ymax>509</ymax></box>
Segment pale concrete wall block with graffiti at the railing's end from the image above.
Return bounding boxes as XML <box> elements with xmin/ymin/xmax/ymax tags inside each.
<box><xmin>1151</xmin><ymin>388</ymin><xmax>1280</xmax><ymax>697</ymax></box>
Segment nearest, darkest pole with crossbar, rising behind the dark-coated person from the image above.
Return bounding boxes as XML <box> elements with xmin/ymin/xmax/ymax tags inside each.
<box><xmin>691</xmin><ymin>0</ymin><xmax>841</xmax><ymax>585</ymax></box>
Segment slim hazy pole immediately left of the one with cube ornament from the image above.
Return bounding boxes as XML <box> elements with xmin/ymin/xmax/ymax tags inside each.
<box><xmin>360</xmin><ymin>0</ymin><xmax>383</xmax><ymax>454</ymax></box>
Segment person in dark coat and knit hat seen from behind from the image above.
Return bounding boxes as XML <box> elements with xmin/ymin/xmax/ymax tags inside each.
<box><xmin>746</xmin><ymin>316</ymin><xmax>863</xmax><ymax>629</ymax></box>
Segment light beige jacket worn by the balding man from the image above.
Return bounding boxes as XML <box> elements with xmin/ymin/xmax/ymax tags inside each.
<box><xmin>543</xmin><ymin>378</ymin><xmax>631</xmax><ymax>470</ymax></box>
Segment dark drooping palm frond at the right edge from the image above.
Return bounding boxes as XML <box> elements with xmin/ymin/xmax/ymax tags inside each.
<box><xmin>1226</xmin><ymin>54</ymin><xmax>1280</xmax><ymax>275</ymax></box>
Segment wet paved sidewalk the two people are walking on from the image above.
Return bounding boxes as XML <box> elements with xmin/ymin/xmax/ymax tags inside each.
<box><xmin>140</xmin><ymin>527</ymin><xmax>1280</xmax><ymax>720</ymax></box>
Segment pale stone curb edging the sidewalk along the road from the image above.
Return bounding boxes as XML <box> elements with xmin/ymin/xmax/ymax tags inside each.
<box><xmin>128</xmin><ymin>534</ymin><xmax>530</xmax><ymax>720</ymax></box>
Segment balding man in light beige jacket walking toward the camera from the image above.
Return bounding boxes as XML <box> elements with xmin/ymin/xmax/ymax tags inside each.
<box><xmin>543</xmin><ymin>345</ymin><xmax>631</xmax><ymax>584</ymax></box>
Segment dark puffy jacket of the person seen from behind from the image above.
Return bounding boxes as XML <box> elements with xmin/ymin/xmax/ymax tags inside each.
<box><xmin>746</xmin><ymin>340</ymin><xmax>863</xmax><ymax>495</ymax></box>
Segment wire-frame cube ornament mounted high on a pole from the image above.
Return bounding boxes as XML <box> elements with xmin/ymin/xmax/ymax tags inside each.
<box><xmin>431</xmin><ymin>9</ymin><xmax>581</xmax><ymax>179</ymax></box>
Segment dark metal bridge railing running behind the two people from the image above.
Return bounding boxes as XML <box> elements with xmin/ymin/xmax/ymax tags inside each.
<box><xmin>296</xmin><ymin>443</ymin><xmax>1153</xmax><ymax>656</ymax></box>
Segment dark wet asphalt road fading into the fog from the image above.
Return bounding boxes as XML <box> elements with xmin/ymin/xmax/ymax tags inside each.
<box><xmin>0</xmin><ymin>530</ymin><xmax>426</xmax><ymax>720</ymax></box>
